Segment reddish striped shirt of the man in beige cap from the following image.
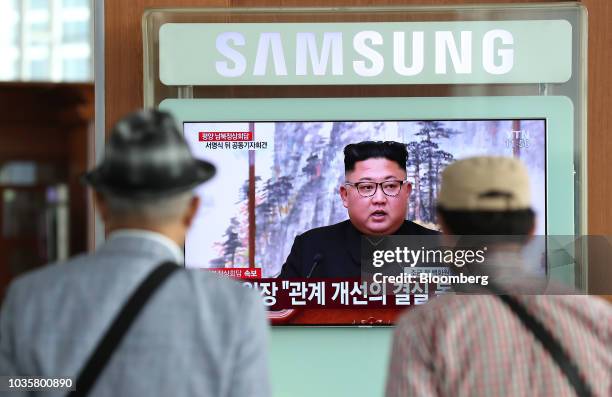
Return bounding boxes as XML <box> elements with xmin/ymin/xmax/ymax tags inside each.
<box><xmin>386</xmin><ymin>295</ymin><xmax>612</xmax><ymax>397</ymax></box>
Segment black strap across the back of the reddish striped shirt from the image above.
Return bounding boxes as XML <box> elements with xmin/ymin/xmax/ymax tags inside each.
<box><xmin>499</xmin><ymin>295</ymin><xmax>593</xmax><ymax>397</ymax></box>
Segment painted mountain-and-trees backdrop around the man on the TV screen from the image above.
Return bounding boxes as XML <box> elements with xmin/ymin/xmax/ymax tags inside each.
<box><xmin>183</xmin><ymin>119</ymin><xmax>546</xmax><ymax>278</ymax></box>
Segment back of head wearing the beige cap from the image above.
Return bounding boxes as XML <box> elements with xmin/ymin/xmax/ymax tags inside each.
<box><xmin>438</xmin><ymin>156</ymin><xmax>535</xmax><ymax>236</ymax></box>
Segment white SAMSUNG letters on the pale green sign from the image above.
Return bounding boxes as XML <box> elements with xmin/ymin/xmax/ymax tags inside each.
<box><xmin>215</xmin><ymin>29</ymin><xmax>514</xmax><ymax>77</ymax></box>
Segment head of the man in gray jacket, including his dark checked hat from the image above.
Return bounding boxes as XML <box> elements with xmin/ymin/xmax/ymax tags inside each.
<box><xmin>83</xmin><ymin>110</ymin><xmax>215</xmax><ymax>240</ymax></box>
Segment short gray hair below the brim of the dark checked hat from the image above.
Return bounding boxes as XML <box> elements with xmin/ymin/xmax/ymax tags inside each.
<box><xmin>104</xmin><ymin>191</ymin><xmax>193</xmax><ymax>224</ymax></box>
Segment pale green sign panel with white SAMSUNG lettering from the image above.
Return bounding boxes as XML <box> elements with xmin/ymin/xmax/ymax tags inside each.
<box><xmin>159</xmin><ymin>20</ymin><xmax>572</xmax><ymax>85</ymax></box>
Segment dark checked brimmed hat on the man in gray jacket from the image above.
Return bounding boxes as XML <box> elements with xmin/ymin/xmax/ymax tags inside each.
<box><xmin>83</xmin><ymin>110</ymin><xmax>215</xmax><ymax>199</ymax></box>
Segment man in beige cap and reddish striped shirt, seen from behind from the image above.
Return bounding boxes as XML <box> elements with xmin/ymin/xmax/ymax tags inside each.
<box><xmin>386</xmin><ymin>157</ymin><xmax>612</xmax><ymax>397</ymax></box>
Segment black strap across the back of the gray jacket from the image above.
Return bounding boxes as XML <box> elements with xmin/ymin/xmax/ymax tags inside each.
<box><xmin>68</xmin><ymin>262</ymin><xmax>179</xmax><ymax>397</ymax></box>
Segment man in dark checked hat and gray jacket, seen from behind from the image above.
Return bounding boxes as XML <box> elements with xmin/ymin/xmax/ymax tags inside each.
<box><xmin>0</xmin><ymin>110</ymin><xmax>269</xmax><ymax>396</ymax></box>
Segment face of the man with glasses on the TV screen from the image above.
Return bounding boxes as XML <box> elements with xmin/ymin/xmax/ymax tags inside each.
<box><xmin>340</xmin><ymin>158</ymin><xmax>411</xmax><ymax>235</ymax></box>
